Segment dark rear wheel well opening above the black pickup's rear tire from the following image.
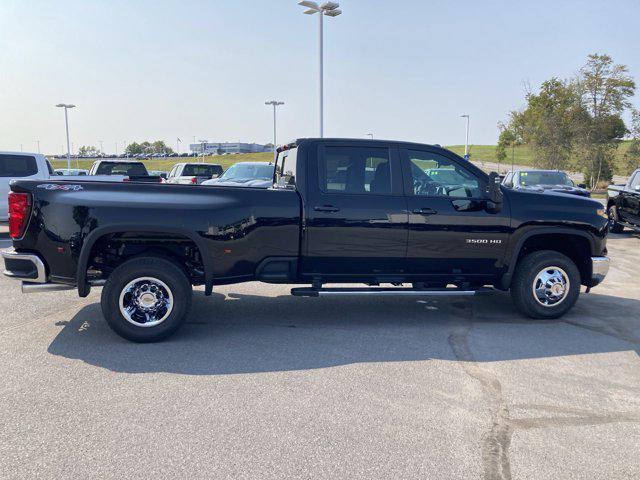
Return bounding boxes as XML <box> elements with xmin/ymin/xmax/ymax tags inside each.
<box><xmin>87</xmin><ymin>232</ymin><xmax>205</xmax><ymax>285</ymax></box>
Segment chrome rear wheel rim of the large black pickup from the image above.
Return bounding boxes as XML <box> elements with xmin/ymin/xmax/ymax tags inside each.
<box><xmin>119</xmin><ymin>277</ymin><xmax>173</xmax><ymax>327</ymax></box>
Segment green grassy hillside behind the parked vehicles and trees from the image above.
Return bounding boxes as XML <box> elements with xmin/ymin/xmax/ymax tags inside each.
<box><xmin>51</xmin><ymin>141</ymin><xmax>631</xmax><ymax>175</ymax></box>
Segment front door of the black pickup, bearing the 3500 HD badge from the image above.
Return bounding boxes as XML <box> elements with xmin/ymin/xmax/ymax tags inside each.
<box><xmin>400</xmin><ymin>147</ymin><xmax>510</xmax><ymax>282</ymax></box>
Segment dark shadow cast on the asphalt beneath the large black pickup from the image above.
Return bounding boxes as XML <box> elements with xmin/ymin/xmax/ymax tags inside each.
<box><xmin>48</xmin><ymin>292</ymin><xmax>640</xmax><ymax>375</ymax></box>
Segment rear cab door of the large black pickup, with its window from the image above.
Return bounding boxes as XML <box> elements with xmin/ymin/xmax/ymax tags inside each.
<box><xmin>302</xmin><ymin>141</ymin><xmax>408</xmax><ymax>278</ymax></box>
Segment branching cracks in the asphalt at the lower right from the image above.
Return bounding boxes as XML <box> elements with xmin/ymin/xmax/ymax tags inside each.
<box><xmin>449</xmin><ymin>299</ymin><xmax>640</xmax><ymax>480</ymax></box>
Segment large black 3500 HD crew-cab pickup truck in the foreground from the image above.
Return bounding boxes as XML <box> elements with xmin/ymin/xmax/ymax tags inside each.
<box><xmin>2</xmin><ymin>139</ymin><xmax>609</xmax><ymax>342</ymax></box>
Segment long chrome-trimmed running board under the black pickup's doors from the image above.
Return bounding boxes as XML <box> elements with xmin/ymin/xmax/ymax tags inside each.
<box><xmin>291</xmin><ymin>287</ymin><xmax>493</xmax><ymax>297</ymax></box>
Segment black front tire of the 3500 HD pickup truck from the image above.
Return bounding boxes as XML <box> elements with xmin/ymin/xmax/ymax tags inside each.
<box><xmin>511</xmin><ymin>250</ymin><xmax>580</xmax><ymax>319</ymax></box>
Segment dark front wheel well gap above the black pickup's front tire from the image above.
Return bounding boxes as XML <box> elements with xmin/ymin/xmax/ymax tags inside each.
<box><xmin>516</xmin><ymin>233</ymin><xmax>591</xmax><ymax>285</ymax></box>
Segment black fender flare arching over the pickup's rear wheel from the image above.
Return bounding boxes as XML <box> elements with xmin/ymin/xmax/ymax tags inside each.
<box><xmin>76</xmin><ymin>225</ymin><xmax>213</xmax><ymax>297</ymax></box>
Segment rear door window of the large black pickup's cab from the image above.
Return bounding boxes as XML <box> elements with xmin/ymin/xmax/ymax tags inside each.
<box><xmin>319</xmin><ymin>146</ymin><xmax>391</xmax><ymax>195</ymax></box>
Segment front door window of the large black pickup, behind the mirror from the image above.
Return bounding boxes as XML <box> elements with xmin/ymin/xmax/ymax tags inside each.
<box><xmin>406</xmin><ymin>150</ymin><xmax>481</xmax><ymax>198</ymax></box>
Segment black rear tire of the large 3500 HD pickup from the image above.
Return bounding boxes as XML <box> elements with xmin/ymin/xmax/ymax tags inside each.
<box><xmin>100</xmin><ymin>257</ymin><xmax>193</xmax><ymax>343</ymax></box>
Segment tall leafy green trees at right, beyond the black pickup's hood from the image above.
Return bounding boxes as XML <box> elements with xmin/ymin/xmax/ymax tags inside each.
<box><xmin>496</xmin><ymin>54</ymin><xmax>640</xmax><ymax>188</ymax></box>
